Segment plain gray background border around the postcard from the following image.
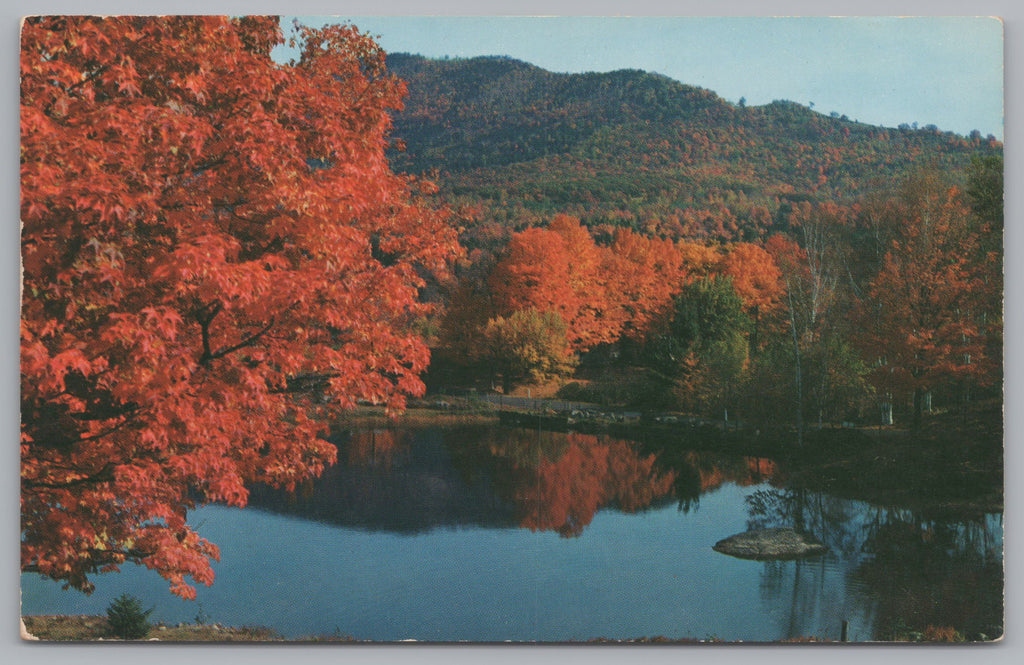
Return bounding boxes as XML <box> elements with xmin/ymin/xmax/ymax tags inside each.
<box><xmin>0</xmin><ymin>0</ymin><xmax>1024</xmax><ymax>665</ymax></box>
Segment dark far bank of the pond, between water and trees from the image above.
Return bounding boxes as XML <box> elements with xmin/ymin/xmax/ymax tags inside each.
<box><xmin>337</xmin><ymin>402</ymin><xmax>1005</xmax><ymax>515</ymax></box>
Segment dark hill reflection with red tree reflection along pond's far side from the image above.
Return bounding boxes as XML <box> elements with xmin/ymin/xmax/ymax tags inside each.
<box><xmin>250</xmin><ymin>427</ymin><xmax>676</xmax><ymax>537</ymax></box>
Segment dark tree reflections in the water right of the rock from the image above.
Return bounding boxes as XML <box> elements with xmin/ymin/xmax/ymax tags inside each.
<box><xmin>748</xmin><ymin>488</ymin><xmax>1002</xmax><ymax>640</ymax></box>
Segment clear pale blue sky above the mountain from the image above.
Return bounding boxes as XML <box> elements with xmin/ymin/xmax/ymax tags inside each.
<box><xmin>284</xmin><ymin>16</ymin><xmax>1004</xmax><ymax>139</ymax></box>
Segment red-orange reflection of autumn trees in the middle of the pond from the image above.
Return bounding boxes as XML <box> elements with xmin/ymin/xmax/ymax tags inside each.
<box><xmin>512</xmin><ymin>433</ymin><xmax>675</xmax><ymax>537</ymax></box>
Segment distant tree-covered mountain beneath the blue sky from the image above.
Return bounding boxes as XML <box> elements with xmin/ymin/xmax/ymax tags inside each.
<box><xmin>388</xmin><ymin>53</ymin><xmax>1002</xmax><ymax>240</ymax></box>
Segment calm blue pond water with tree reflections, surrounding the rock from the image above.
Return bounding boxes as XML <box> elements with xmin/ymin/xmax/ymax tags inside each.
<box><xmin>22</xmin><ymin>428</ymin><xmax>1002</xmax><ymax>641</ymax></box>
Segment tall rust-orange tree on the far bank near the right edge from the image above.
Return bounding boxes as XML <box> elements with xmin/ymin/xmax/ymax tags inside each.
<box><xmin>861</xmin><ymin>172</ymin><xmax>999</xmax><ymax>427</ymax></box>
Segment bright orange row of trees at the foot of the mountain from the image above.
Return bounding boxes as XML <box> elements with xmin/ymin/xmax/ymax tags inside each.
<box><xmin>468</xmin><ymin>215</ymin><xmax>781</xmax><ymax>352</ymax></box>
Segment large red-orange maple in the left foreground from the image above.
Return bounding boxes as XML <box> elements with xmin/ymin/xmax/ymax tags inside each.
<box><xmin>20</xmin><ymin>16</ymin><xmax>456</xmax><ymax>597</ymax></box>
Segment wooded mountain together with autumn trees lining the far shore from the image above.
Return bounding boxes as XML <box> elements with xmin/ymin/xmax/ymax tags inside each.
<box><xmin>380</xmin><ymin>54</ymin><xmax>1002</xmax><ymax>432</ymax></box>
